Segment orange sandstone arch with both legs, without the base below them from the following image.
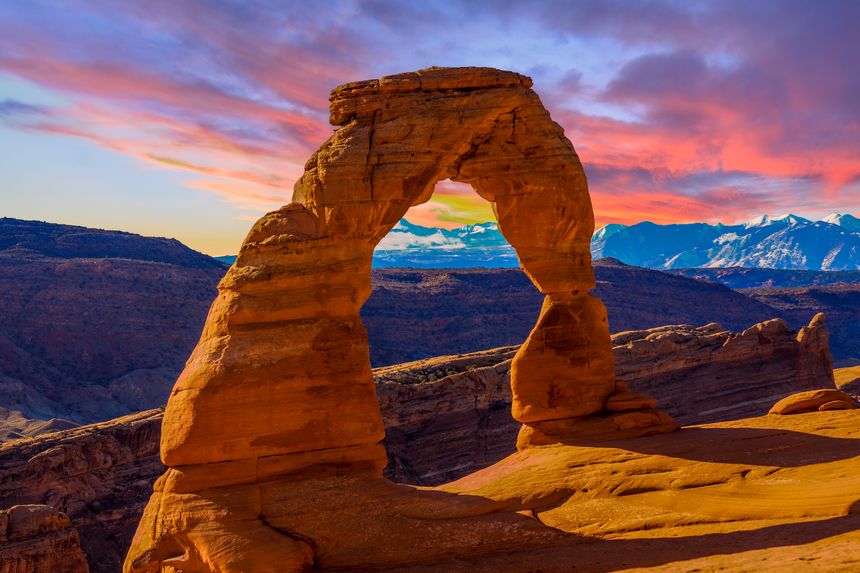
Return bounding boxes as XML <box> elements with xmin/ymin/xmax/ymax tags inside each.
<box><xmin>162</xmin><ymin>68</ymin><xmax>615</xmax><ymax>470</ymax></box>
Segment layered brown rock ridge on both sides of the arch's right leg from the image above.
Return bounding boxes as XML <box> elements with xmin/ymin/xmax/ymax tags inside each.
<box><xmin>374</xmin><ymin>317</ymin><xmax>833</xmax><ymax>485</ymax></box>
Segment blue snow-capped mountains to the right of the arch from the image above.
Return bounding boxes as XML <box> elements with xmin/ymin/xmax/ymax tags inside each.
<box><xmin>591</xmin><ymin>213</ymin><xmax>860</xmax><ymax>270</ymax></box>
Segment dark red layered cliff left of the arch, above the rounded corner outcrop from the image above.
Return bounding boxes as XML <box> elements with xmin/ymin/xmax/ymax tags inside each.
<box><xmin>0</xmin><ymin>410</ymin><xmax>164</xmax><ymax>573</ymax></box>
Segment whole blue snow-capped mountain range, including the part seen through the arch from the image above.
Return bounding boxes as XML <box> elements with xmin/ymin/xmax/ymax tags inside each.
<box><xmin>374</xmin><ymin>213</ymin><xmax>860</xmax><ymax>271</ymax></box>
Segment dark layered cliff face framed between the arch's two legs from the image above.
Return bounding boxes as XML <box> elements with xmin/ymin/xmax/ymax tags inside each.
<box><xmin>374</xmin><ymin>346</ymin><xmax>520</xmax><ymax>484</ymax></box>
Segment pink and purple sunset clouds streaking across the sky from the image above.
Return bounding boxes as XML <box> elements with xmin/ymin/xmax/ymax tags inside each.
<box><xmin>0</xmin><ymin>0</ymin><xmax>860</xmax><ymax>232</ymax></box>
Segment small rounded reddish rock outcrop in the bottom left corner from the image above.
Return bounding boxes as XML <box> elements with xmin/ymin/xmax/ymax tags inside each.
<box><xmin>0</xmin><ymin>505</ymin><xmax>89</xmax><ymax>573</ymax></box>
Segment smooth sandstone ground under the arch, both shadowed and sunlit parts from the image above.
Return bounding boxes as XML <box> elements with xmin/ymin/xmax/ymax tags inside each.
<box><xmin>129</xmin><ymin>411</ymin><xmax>860</xmax><ymax>573</ymax></box>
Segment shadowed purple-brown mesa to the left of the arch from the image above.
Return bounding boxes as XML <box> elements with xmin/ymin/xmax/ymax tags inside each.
<box><xmin>0</xmin><ymin>214</ymin><xmax>227</xmax><ymax>441</ymax></box>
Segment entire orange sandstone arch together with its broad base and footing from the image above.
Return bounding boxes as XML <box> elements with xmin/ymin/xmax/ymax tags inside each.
<box><xmin>125</xmin><ymin>68</ymin><xmax>676</xmax><ymax>573</ymax></box>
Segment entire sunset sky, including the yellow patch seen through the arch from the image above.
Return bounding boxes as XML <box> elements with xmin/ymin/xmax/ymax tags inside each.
<box><xmin>0</xmin><ymin>0</ymin><xmax>860</xmax><ymax>255</ymax></box>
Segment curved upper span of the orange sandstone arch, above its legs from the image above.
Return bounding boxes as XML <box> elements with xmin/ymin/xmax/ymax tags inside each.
<box><xmin>293</xmin><ymin>68</ymin><xmax>594</xmax><ymax>293</ymax></box>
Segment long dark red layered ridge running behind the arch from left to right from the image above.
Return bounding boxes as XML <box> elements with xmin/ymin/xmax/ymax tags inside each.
<box><xmin>0</xmin><ymin>325</ymin><xmax>840</xmax><ymax>573</ymax></box>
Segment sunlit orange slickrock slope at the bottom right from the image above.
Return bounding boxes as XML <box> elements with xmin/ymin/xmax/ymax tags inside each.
<box><xmin>391</xmin><ymin>410</ymin><xmax>860</xmax><ymax>573</ymax></box>
